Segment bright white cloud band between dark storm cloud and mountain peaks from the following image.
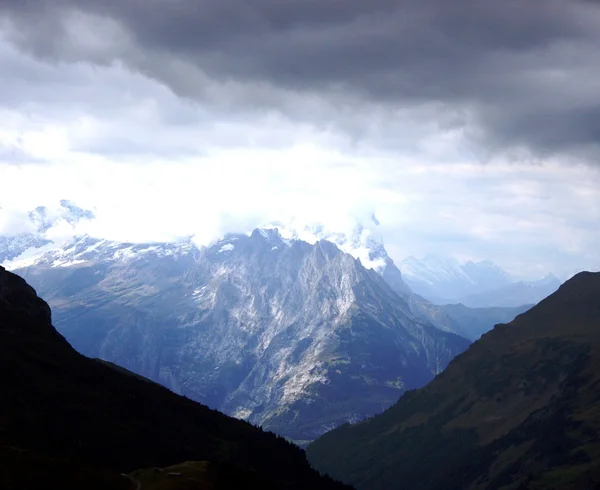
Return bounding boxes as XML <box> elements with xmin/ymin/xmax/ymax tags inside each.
<box><xmin>0</xmin><ymin>39</ymin><xmax>600</xmax><ymax>276</ymax></box>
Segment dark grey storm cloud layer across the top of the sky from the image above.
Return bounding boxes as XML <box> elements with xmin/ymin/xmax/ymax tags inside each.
<box><xmin>0</xmin><ymin>0</ymin><xmax>600</xmax><ymax>157</ymax></box>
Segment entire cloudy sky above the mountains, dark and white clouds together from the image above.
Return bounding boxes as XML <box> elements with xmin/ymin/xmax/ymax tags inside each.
<box><xmin>0</xmin><ymin>0</ymin><xmax>600</xmax><ymax>278</ymax></box>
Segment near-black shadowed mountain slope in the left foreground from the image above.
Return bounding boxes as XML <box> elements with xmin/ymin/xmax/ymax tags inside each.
<box><xmin>0</xmin><ymin>267</ymin><xmax>341</xmax><ymax>489</ymax></box>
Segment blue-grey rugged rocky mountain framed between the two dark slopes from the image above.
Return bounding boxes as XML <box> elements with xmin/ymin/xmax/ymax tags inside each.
<box><xmin>15</xmin><ymin>229</ymin><xmax>468</xmax><ymax>440</ymax></box>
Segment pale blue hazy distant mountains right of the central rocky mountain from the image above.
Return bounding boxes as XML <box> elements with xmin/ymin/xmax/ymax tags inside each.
<box><xmin>399</xmin><ymin>257</ymin><xmax>561</xmax><ymax>308</ymax></box>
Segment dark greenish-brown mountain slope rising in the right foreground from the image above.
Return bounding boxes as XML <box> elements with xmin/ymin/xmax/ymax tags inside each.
<box><xmin>308</xmin><ymin>272</ymin><xmax>600</xmax><ymax>490</ymax></box>
